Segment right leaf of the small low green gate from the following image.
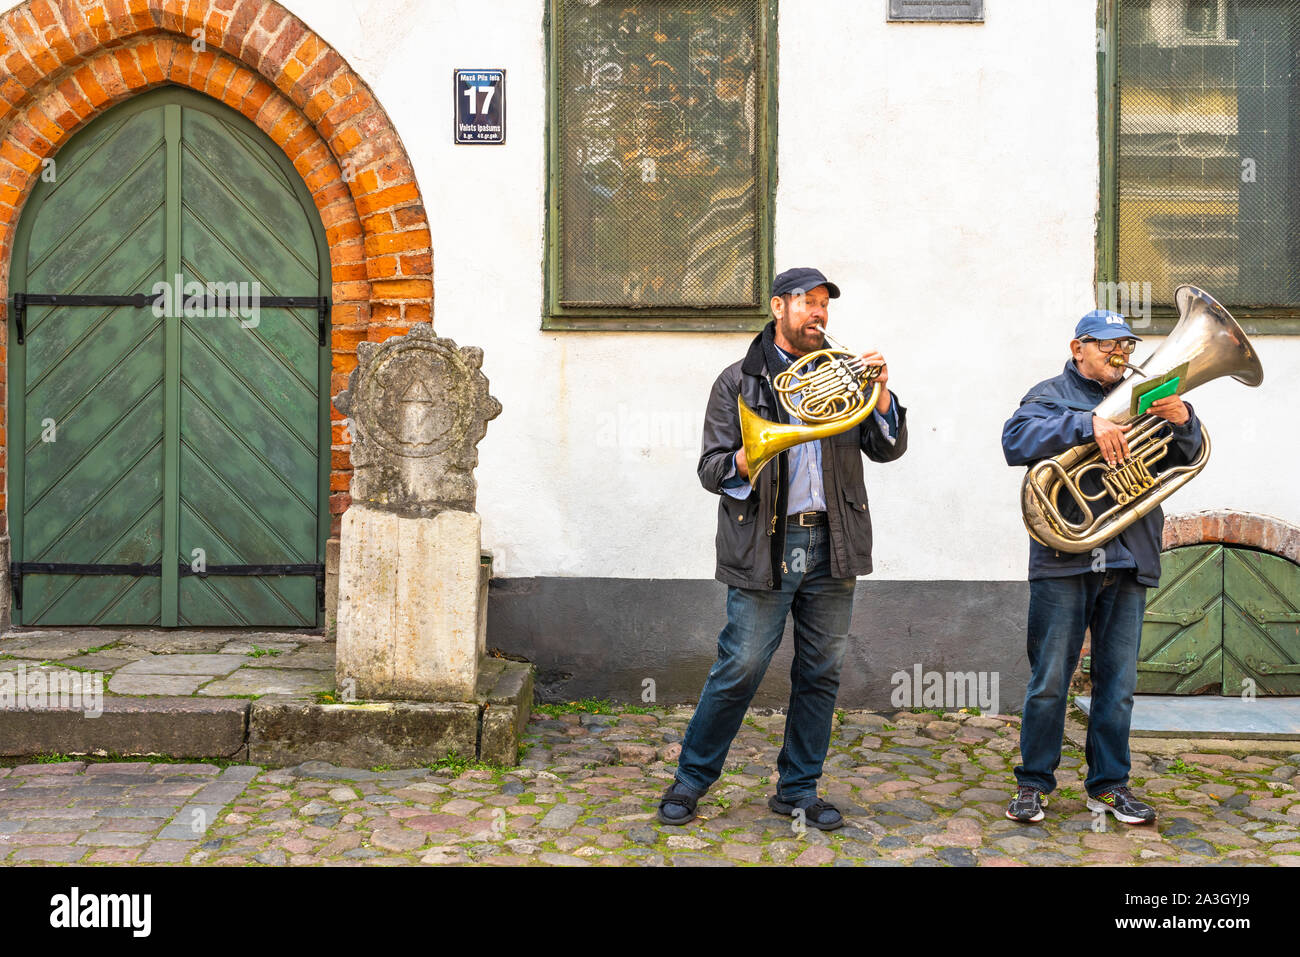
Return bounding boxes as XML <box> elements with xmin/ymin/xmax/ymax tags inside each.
<box><xmin>1223</xmin><ymin>549</ymin><xmax>1300</xmax><ymax>696</ymax></box>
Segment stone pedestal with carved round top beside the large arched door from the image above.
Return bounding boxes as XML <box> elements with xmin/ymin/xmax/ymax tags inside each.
<box><xmin>334</xmin><ymin>324</ymin><xmax>501</xmax><ymax>702</ymax></box>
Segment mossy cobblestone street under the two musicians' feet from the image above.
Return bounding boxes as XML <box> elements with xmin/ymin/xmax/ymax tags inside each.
<box><xmin>0</xmin><ymin>707</ymin><xmax>1300</xmax><ymax>866</ymax></box>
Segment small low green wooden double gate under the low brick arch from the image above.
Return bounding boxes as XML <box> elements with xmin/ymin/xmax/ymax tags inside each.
<box><xmin>1138</xmin><ymin>545</ymin><xmax>1300</xmax><ymax>697</ymax></box>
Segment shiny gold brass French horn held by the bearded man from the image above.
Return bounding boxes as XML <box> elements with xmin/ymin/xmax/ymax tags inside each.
<box><xmin>736</xmin><ymin>328</ymin><xmax>881</xmax><ymax>486</ymax></box>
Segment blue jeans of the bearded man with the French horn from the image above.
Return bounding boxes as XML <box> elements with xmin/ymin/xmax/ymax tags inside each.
<box><xmin>677</xmin><ymin>525</ymin><xmax>857</xmax><ymax>802</ymax></box>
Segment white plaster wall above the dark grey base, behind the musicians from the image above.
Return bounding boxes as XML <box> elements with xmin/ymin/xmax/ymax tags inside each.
<box><xmin>290</xmin><ymin>0</ymin><xmax>1300</xmax><ymax>580</ymax></box>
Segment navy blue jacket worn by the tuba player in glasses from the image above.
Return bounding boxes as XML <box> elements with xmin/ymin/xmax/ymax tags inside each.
<box><xmin>1002</xmin><ymin>359</ymin><xmax>1201</xmax><ymax>586</ymax></box>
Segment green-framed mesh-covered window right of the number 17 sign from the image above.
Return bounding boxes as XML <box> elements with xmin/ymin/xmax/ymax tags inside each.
<box><xmin>542</xmin><ymin>0</ymin><xmax>776</xmax><ymax>330</ymax></box>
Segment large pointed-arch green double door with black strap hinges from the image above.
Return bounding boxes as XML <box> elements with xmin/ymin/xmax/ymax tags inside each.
<box><xmin>9</xmin><ymin>87</ymin><xmax>330</xmax><ymax>627</ymax></box>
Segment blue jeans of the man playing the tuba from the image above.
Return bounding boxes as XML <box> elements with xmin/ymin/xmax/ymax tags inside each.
<box><xmin>1015</xmin><ymin>568</ymin><xmax>1147</xmax><ymax>796</ymax></box>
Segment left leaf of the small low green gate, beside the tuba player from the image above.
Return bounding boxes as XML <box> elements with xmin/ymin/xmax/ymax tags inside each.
<box><xmin>1138</xmin><ymin>545</ymin><xmax>1223</xmax><ymax>694</ymax></box>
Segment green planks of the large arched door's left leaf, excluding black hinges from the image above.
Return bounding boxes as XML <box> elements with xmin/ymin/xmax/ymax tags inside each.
<box><xmin>9</xmin><ymin>102</ymin><xmax>166</xmax><ymax>624</ymax></box>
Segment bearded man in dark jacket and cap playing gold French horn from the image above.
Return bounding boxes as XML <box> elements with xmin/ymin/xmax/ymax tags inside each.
<box><xmin>659</xmin><ymin>268</ymin><xmax>907</xmax><ymax>830</ymax></box>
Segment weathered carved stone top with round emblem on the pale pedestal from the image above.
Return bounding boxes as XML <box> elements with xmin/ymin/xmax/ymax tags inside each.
<box><xmin>334</xmin><ymin>322</ymin><xmax>501</xmax><ymax>516</ymax></box>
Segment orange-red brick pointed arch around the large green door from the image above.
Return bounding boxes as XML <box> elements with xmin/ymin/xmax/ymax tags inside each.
<box><xmin>0</xmin><ymin>0</ymin><xmax>433</xmax><ymax>534</ymax></box>
